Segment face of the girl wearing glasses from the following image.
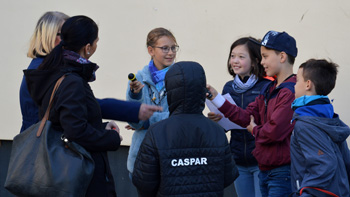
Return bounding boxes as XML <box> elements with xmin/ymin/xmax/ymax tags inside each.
<box><xmin>148</xmin><ymin>36</ymin><xmax>176</xmax><ymax>70</ymax></box>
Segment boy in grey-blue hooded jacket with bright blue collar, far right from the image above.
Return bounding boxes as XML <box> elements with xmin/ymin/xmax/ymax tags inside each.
<box><xmin>291</xmin><ymin>59</ymin><xmax>350</xmax><ymax>197</ymax></box>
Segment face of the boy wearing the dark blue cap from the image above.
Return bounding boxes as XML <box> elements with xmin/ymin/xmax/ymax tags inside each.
<box><xmin>261</xmin><ymin>46</ymin><xmax>281</xmax><ymax>77</ymax></box>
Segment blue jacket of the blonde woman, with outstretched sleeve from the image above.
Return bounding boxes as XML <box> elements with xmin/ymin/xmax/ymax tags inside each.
<box><xmin>19</xmin><ymin>57</ymin><xmax>141</xmax><ymax>132</ymax></box>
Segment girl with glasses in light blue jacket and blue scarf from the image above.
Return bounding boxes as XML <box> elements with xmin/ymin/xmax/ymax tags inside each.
<box><xmin>126</xmin><ymin>28</ymin><xmax>179</xmax><ymax>174</ymax></box>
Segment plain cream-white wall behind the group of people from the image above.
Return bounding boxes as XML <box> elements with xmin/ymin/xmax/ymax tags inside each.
<box><xmin>0</xmin><ymin>0</ymin><xmax>350</xmax><ymax>145</ymax></box>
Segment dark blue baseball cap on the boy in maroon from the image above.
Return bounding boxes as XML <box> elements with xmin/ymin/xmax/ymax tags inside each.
<box><xmin>261</xmin><ymin>31</ymin><xmax>298</xmax><ymax>57</ymax></box>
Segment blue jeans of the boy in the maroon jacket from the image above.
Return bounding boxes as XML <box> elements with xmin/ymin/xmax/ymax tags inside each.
<box><xmin>259</xmin><ymin>165</ymin><xmax>292</xmax><ymax>197</ymax></box>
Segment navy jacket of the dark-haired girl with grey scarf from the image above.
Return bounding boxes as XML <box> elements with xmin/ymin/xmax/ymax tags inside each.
<box><xmin>222</xmin><ymin>79</ymin><xmax>270</xmax><ymax>166</ymax></box>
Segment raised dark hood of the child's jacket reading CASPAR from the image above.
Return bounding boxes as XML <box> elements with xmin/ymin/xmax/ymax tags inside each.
<box><xmin>165</xmin><ymin>62</ymin><xmax>207</xmax><ymax>115</ymax></box>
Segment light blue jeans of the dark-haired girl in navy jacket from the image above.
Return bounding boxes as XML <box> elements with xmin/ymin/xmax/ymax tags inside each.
<box><xmin>235</xmin><ymin>165</ymin><xmax>261</xmax><ymax>197</ymax></box>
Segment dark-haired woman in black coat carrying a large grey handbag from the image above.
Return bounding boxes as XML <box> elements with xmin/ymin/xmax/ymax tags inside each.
<box><xmin>24</xmin><ymin>16</ymin><xmax>122</xmax><ymax>196</ymax></box>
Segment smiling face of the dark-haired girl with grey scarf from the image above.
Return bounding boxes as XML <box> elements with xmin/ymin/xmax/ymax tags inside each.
<box><xmin>230</xmin><ymin>45</ymin><xmax>252</xmax><ymax>78</ymax></box>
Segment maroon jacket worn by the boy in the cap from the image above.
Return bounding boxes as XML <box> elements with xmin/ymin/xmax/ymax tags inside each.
<box><xmin>219</xmin><ymin>75</ymin><xmax>296</xmax><ymax>170</ymax></box>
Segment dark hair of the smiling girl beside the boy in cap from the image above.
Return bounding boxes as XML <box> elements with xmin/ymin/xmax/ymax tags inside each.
<box><xmin>227</xmin><ymin>37</ymin><xmax>266</xmax><ymax>79</ymax></box>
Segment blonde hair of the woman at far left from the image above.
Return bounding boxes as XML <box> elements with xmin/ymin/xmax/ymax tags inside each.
<box><xmin>27</xmin><ymin>12</ymin><xmax>69</xmax><ymax>58</ymax></box>
